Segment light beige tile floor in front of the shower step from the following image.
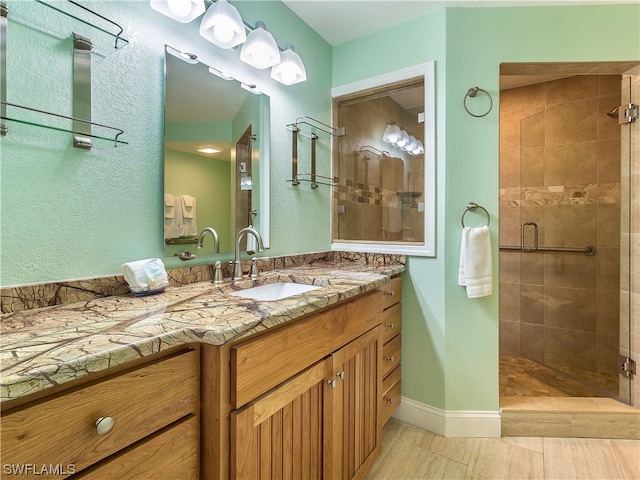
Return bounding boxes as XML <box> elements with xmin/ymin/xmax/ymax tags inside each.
<box><xmin>366</xmin><ymin>418</ymin><xmax>640</xmax><ymax>480</ymax></box>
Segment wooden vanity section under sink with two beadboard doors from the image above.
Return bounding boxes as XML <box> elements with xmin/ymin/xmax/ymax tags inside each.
<box><xmin>201</xmin><ymin>291</ymin><xmax>383</xmax><ymax>479</ymax></box>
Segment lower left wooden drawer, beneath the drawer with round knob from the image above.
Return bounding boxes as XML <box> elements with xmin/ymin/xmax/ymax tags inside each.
<box><xmin>77</xmin><ymin>416</ymin><xmax>198</xmax><ymax>480</ymax></box>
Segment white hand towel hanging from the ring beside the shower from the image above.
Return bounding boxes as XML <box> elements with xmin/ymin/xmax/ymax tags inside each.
<box><xmin>458</xmin><ymin>225</ymin><xmax>493</xmax><ymax>298</ymax></box>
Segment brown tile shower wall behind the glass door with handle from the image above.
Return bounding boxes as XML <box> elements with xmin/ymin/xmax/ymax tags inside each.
<box><xmin>500</xmin><ymin>75</ymin><xmax>621</xmax><ymax>386</ymax></box>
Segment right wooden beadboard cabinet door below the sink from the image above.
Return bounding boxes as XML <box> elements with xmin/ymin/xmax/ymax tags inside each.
<box><xmin>324</xmin><ymin>327</ymin><xmax>382</xmax><ymax>479</ymax></box>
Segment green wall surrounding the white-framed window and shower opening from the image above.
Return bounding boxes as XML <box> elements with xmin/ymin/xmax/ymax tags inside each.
<box><xmin>333</xmin><ymin>5</ymin><xmax>640</xmax><ymax>411</ymax></box>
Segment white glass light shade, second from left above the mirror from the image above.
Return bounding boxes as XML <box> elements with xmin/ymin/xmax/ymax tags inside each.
<box><xmin>200</xmin><ymin>0</ymin><xmax>247</xmax><ymax>49</ymax></box>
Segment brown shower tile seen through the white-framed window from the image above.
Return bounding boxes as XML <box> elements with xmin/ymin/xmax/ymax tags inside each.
<box><xmin>333</xmin><ymin>93</ymin><xmax>424</xmax><ymax>242</ymax></box>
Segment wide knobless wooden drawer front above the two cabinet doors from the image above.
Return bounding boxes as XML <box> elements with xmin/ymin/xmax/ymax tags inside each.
<box><xmin>231</xmin><ymin>291</ymin><xmax>382</xmax><ymax>409</ymax></box>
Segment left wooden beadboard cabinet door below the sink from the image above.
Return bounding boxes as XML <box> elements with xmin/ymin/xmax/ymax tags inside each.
<box><xmin>231</xmin><ymin>359</ymin><xmax>331</xmax><ymax>480</ymax></box>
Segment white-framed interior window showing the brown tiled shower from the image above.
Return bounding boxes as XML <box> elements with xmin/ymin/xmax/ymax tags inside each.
<box><xmin>333</xmin><ymin>64</ymin><xmax>435</xmax><ymax>256</ymax></box>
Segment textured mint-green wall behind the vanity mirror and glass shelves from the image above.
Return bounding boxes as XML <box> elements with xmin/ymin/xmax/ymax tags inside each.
<box><xmin>0</xmin><ymin>0</ymin><xmax>331</xmax><ymax>286</ymax></box>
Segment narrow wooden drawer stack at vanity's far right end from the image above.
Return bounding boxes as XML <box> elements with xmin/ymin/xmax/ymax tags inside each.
<box><xmin>381</xmin><ymin>276</ymin><xmax>402</xmax><ymax>424</ymax></box>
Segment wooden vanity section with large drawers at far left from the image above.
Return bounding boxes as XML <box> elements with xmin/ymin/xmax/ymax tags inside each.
<box><xmin>0</xmin><ymin>349</ymin><xmax>199</xmax><ymax>479</ymax></box>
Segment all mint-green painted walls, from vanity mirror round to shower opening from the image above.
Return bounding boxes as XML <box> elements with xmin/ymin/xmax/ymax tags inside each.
<box><xmin>0</xmin><ymin>0</ymin><xmax>640</xmax><ymax>411</ymax></box>
